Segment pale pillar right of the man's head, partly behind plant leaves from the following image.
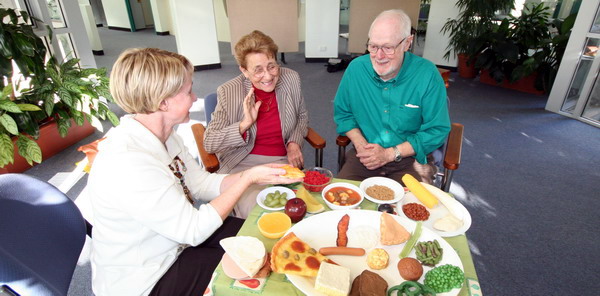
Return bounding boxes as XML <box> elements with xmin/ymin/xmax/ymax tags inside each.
<box><xmin>423</xmin><ymin>0</ymin><xmax>459</xmax><ymax>67</ymax></box>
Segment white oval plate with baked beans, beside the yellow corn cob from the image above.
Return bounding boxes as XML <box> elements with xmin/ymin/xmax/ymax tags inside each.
<box><xmin>396</xmin><ymin>182</ymin><xmax>472</xmax><ymax>237</ymax></box>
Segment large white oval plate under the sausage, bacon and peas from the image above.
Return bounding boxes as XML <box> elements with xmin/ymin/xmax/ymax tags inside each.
<box><xmin>287</xmin><ymin>210</ymin><xmax>464</xmax><ymax>296</ymax></box>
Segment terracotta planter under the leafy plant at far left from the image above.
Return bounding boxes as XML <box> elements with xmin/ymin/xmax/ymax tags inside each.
<box><xmin>0</xmin><ymin>121</ymin><xmax>95</xmax><ymax>174</ymax></box>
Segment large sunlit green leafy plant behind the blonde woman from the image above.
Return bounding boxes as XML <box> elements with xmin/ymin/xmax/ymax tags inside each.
<box><xmin>0</xmin><ymin>8</ymin><xmax>119</xmax><ymax>168</ymax></box>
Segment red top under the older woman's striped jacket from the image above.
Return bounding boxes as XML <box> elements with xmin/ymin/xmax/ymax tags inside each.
<box><xmin>244</xmin><ymin>86</ymin><xmax>287</xmax><ymax>156</ymax></box>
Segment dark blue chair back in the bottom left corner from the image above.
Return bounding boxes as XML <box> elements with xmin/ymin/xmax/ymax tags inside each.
<box><xmin>0</xmin><ymin>174</ymin><xmax>86</xmax><ymax>295</ymax></box>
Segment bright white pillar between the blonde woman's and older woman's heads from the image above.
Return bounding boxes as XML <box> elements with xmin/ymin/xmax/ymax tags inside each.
<box><xmin>169</xmin><ymin>0</ymin><xmax>221</xmax><ymax>66</ymax></box>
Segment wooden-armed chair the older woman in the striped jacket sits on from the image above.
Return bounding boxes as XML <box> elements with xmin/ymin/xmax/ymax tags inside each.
<box><xmin>192</xmin><ymin>93</ymin><xmax>327</xmax><ymax>173</ymax></box>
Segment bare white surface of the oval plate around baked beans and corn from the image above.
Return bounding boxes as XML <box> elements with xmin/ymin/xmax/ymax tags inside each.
<box><xmin>396</xmin><ymin>182</ymin><xmax>472</xmax><ymax>237</ymax></box>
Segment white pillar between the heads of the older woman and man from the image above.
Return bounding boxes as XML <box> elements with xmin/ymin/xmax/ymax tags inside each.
<box><xmin>305</xmin><ymin>0</ymin><xmax>340</xmax><ymax>58</ymax></box>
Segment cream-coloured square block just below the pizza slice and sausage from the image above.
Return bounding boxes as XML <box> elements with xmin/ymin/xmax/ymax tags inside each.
<box><xmin>315</xmin><ymin>262</ymin><xmax>350</xmax><ymax>296</ymax></box>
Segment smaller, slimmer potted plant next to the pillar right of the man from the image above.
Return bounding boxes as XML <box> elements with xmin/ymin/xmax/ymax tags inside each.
<box><xmin>441</xmin><ymin>0</ymin><xmax>513</xmax><ymax>78</ymax></box>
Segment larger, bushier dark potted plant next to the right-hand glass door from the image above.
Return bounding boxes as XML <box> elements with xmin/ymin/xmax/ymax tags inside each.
<box><xmin>476</xmin><ymin>4</ymin><xmax>576</xmax><ymax>94</ymax></box>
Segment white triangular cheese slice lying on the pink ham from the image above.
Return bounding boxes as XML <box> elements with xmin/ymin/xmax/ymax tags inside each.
<box><xmin>219</xmin><ymin>236</ymin><xmax>266</xmax><ymax>277</ymax></box>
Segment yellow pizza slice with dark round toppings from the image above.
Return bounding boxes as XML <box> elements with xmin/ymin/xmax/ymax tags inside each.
<box><xmin>271</xmin><ymin>232</ymin><xmax>334</xmax><ymax>277</ymax></box>
